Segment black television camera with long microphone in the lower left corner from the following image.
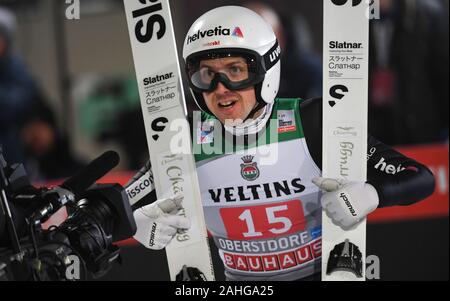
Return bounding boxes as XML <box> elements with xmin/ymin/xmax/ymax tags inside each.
<box><xmin>0</xmin><ymin>147</ymin><xmax>136</xmax><ymax>281</ymax></box>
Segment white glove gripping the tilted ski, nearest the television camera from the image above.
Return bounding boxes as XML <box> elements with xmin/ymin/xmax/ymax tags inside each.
<box><xmin>133</xmin><ymin>195</ymin><xmax>191</xmax><ymax>250</ymax></box>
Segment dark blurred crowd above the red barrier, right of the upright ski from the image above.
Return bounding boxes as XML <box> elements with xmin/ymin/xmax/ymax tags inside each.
<box><xmin>369</xmin><ymin>0</ymin><xmax>449</xmax><ymax>145</ymax></box>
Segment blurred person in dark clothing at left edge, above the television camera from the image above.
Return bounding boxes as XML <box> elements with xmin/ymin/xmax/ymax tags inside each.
<box><xmin>0</xmin><ymin>8</ymin><xmax>85</xmax><ymax>181</ymax></box>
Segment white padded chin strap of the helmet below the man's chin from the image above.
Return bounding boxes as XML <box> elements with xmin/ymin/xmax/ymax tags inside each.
<box><xmin>224</xmin><ymin>103</ymin><xmax>273</xmax><ymax>136</ymax></box>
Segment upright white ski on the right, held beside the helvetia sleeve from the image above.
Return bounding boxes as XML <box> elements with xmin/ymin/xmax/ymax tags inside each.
<box><xmin>322</xmin><ymin>0</ymin><xmax>369</xmax><ymax>281</ymax></box>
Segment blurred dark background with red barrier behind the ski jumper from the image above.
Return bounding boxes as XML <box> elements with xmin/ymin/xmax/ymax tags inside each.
<box><xmin>0</xmin><ymin>0</ymin><xmax>449</xmax><ymax>280</ymax></box>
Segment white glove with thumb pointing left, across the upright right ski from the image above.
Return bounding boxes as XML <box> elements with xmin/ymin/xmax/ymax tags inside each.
<box><xmin>312</xmin><ymin>177</ymin><xmax>379</xmax><ymax>229</ymax></box>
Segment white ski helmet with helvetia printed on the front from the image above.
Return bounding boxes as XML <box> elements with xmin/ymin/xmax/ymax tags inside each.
<box><xmin>183</xmin><ymin>6</ymin><xmax>281</xmax><ymax>118</ymax></box>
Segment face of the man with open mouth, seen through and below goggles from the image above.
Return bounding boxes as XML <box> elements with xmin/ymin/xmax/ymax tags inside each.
<box><xmin>200</xmin><ymin>57</ymin><xmax>256</xmax><ymax>123</ymax></box>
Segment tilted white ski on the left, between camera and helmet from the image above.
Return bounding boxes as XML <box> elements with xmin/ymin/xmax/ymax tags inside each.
<box><xmin>124</xmin><ymin>0</ymin><xmax>214</xmax><ymax>281</ymax></box>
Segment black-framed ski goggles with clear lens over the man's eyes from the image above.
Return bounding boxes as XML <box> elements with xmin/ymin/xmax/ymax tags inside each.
<box><xmin>186</xmin><ymin>48</ymin><xmax>266</xmax><ymax>92</ymax></box>
